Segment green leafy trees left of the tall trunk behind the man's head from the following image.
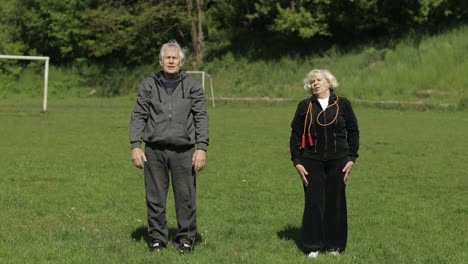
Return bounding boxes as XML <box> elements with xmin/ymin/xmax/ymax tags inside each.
<box><xmin>0</xmin><ymin>0</ymin><xmax>187</xmax><ymax>65</ymax></box>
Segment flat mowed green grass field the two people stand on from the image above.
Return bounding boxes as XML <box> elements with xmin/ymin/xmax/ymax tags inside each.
<box><xmin>0</xmin><ymin>97</ymin><xmax>468</xmax><ymax>263</ymax></box>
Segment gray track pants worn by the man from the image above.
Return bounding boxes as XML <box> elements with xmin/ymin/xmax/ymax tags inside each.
<box><xmin>145</xmin><ymin>145</ymin><xmax>197</xmax><ymax>244</ymax></box>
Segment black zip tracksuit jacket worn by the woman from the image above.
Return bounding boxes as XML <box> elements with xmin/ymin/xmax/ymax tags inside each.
<box><xmin>289</xmin><ymin>92</ymin><xmax>359</xmax><ymax>166</ymax></box>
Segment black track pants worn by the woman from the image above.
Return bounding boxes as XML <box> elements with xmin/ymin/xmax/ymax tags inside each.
<box><xmin>302</xmin><ymin>157</ymin><xmax>348</xmax><ymax>252</ymax></box>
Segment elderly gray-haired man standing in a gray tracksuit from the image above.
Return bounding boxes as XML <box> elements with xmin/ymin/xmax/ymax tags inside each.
<box><xmin>130</xmin><ymin>41</ymin><xmax>209</xmax><ymax>254</ymax></box>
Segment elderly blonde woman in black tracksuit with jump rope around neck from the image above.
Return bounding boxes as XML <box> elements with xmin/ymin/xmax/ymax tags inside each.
<box><xmin>290</xmin><ymin>69</ymin><xmax>359</xmax><ymax>258</ymax></box>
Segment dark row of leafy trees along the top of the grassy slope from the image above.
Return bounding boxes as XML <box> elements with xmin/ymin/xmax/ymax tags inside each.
<box><xmin>0</xmin><ymin>0</ymin><xmax>468</xmax><ymax>66</ymax></box>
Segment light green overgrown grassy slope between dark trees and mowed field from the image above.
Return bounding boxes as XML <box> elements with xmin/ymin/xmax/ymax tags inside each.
<box><xmin>0</xmin><ymin>26</ymin><xmax>468</xmax><ymax>108</ymax></box>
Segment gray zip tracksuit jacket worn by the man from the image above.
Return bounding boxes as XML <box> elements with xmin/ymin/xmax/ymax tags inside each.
<box><xmin>130</xmin><ymin>71</ymin><xmax>209</xmax><ymax>150</ymax></box>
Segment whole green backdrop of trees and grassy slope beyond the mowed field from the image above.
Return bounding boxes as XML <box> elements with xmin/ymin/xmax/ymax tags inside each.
<box><xmin>0</xmin><ymin>0</ymin><xmax>468</xmax><ymax>107</ymax></box>
